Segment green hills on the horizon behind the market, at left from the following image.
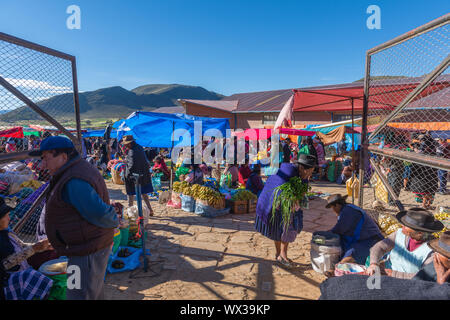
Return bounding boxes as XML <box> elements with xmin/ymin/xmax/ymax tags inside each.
<box><xmin>0</xmin><ymin>84</ymin><xmax>224</xmax><ymax>122</ymax></box>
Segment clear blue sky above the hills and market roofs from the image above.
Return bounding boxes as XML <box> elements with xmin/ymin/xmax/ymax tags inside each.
<box><xmin>0</xmin><ymin>0</ymin><xmax>450</xmax><ymax>95</ymax></box>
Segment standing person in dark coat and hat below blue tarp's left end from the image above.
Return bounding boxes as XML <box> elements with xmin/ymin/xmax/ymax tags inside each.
<box><xmin>122</xmin><ymin>135</ymin><xmax>153</xmax><ymax>218</ymax></box>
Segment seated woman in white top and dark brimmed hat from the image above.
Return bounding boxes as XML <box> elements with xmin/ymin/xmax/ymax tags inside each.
<box><xmin>366</xmin><ymin>207</ymin><xmax>444</xmax><ymax>279</ymax></box>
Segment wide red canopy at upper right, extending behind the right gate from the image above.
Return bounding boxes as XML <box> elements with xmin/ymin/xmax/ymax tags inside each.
<box><xmin>293</xmin><ymin>76</ymin><xmax>450</xmax><ymax>112</ymax></box>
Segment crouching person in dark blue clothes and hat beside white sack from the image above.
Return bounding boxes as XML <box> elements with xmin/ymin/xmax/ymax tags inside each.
<box><xmin>326</xmin><ymin>194</ymin><xmax>384</xmax><ymax>265</ymax></box>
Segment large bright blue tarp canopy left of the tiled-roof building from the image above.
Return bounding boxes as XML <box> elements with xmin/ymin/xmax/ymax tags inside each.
<box><xmin>117</xmin><ymin>111</ymin><xmax>230</xmax><ymax>148</ymax></box>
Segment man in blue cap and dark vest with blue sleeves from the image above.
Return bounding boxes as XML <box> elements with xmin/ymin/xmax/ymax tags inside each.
<box><xmin>29</xmin><ymin>137</ymin><xmax>119</xmax><ymax>300</ymax></box>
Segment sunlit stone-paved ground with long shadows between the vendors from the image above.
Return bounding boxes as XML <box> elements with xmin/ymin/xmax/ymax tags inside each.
<box><xmin>105</xmin><ymin>180</ymin><xmax>356</xmax><ymax>300</ymax></box>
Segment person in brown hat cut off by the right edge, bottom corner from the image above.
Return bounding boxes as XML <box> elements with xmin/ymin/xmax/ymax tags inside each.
<box><xmin>413</xmin><ymin>231</ymin><xmax>450</xmax><ymax>284</ymax></box>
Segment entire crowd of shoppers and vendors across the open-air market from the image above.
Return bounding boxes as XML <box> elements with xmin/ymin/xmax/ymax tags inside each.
<box><xmin>0</xmin><ymin>128</ymin><xmax>450</xmax><ymax>300</ymax></box>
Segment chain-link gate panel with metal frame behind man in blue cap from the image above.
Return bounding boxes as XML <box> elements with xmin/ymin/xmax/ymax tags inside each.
<box><xmin>0</xmin><ymin>33</ymin><xmax>81</xmax><ymax>242</ymax></box>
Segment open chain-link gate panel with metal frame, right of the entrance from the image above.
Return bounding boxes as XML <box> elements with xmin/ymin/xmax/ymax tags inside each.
<box><xmin>361</xmin><ymin>15</ymin><xmax>450</xmax><ymax>235</ymax></box>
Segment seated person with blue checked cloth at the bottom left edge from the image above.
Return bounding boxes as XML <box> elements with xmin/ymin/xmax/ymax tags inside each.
<box><xmin>0</xmin><ymin>198</ymin><xmax>53</xmax><ymax>300</ymax></box>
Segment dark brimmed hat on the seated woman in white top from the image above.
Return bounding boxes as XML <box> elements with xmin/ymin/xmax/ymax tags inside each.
<box><xmin>395</xmin><ymin>207</ymin><xmax>444</xmax><ymax>232</ymax></box>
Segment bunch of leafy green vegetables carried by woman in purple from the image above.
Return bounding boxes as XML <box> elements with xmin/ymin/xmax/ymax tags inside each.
<box><xmin>272</xmin><ymin>177</ymin><xmax>308</xmax><ymax>228</ymax></box>
